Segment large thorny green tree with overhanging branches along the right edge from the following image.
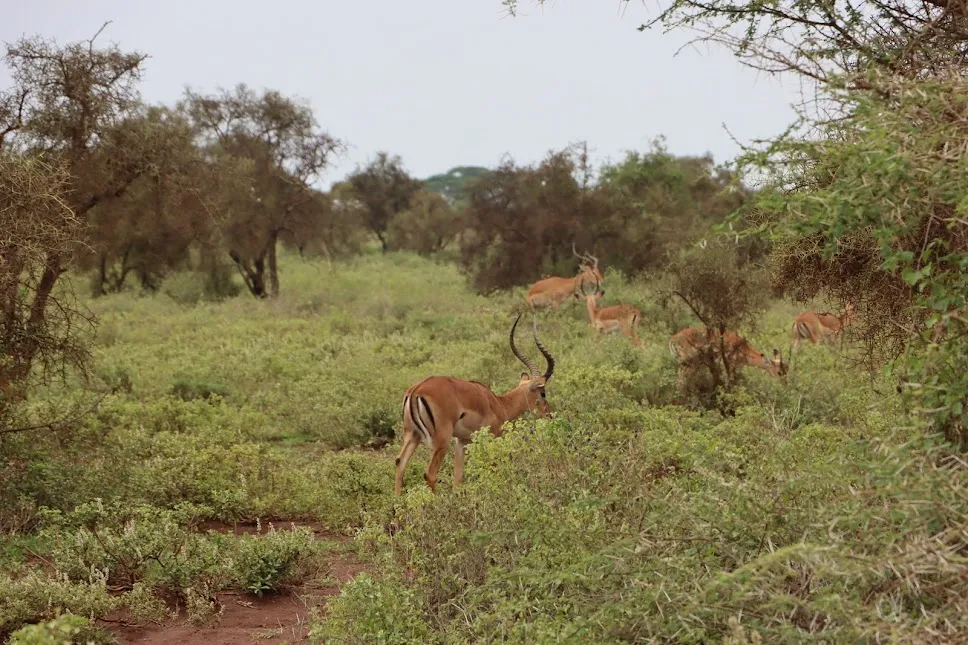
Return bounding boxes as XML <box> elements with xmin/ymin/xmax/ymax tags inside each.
<box><xmin>504</xmin><ymin>0</ymin><xmax>968</xmax><ymax>443</ymax></box>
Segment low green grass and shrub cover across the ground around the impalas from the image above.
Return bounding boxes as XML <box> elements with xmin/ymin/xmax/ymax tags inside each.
<box><xmin>0</xmin><ymin>249</ymin><xmax>968</xmax><ymax>643</ymax></box>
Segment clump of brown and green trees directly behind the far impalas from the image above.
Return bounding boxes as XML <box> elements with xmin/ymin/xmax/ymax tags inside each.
<box><xmin>461</xmin><ymin>141</ymin><xmax>747</xmax><ymax>289</ymax></box>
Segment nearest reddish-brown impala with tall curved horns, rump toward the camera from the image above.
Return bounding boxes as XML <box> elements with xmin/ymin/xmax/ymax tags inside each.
<box><xmin>394</xmin><ymin>314</ymin><xmax>555</xmax><ymax>495</ymax></box>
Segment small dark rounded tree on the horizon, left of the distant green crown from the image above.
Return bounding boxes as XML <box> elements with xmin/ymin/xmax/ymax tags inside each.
<box><xmin>344</xmin><ymin>152</ymin><xmax>421</xmax><ymax>253</ymax></box>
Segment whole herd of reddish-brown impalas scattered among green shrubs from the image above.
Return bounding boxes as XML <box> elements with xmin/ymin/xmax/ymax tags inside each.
<box><xmin>394</xmin><ymin>245</ymin><xmax>856</xmax><ymax>495</ymax></box>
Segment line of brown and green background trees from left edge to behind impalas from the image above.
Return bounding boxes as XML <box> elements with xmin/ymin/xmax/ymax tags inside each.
<box><xmin>0</xmin><ymin>22</ymin><xmax>744</xmax><ymax>297</ymax></box>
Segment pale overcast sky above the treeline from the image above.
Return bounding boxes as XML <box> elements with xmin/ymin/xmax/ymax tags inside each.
<box><xmin>0</xmin><ymin>0</ymin><xmax>796</xmax><ymax>185</ymax></box>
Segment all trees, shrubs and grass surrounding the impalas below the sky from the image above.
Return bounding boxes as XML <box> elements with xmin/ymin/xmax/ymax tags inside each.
<box><xmin>0</xmin><ymin>0</ymin><xmax>968</xmax><ymax>643</ymax></box>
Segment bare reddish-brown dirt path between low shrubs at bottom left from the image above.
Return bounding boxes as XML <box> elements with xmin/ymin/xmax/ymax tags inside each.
<box><xmin>104</xmin><ymin>522</ymin><xmax>364</xmax><ymax>645</ymax></box>
